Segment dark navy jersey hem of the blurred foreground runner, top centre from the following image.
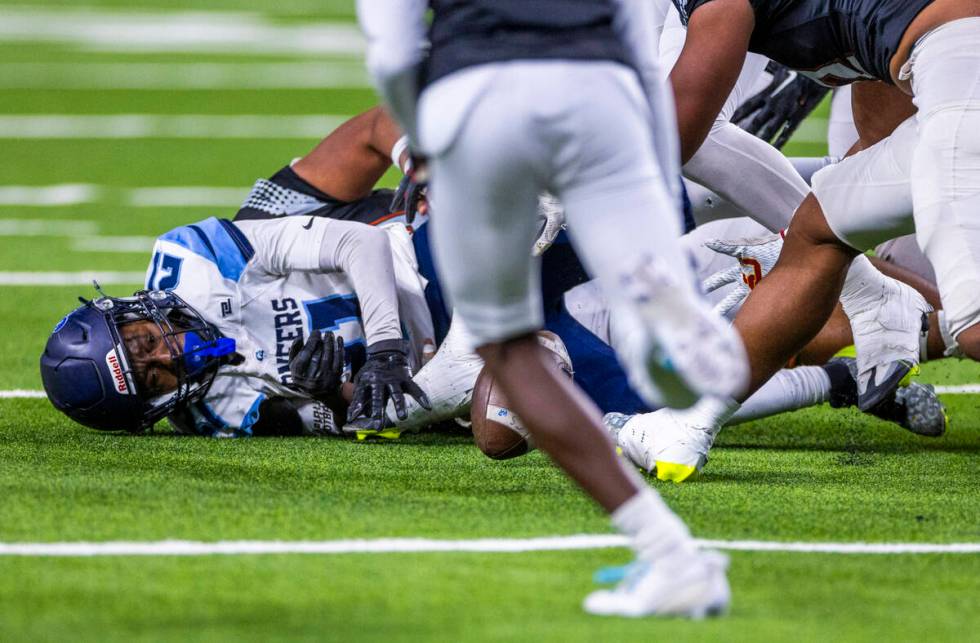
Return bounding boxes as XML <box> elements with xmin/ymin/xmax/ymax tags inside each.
<box><xmin>424</xmin><ymin>0</ymin><xmax>628</xmax><ymax>83</ymax></box>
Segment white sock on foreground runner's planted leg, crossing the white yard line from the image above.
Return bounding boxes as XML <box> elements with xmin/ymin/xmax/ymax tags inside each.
<box><xmin>611</xmin><ymin>488</ymin><xmax>697</xmax><ymax>561</ymax></box>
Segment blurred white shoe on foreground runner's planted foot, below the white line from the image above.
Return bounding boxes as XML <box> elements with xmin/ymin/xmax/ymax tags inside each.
<box><xmin>582</xmin><ymin>551</ymin><xmax>731</xmax><ymax>619</ymax></box>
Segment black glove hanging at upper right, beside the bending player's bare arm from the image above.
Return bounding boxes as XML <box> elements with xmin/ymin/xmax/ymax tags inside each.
<box><xmin>732</xmin><ymin>61</ymin><xmax>830</xmax><ymax>149</ymax></box>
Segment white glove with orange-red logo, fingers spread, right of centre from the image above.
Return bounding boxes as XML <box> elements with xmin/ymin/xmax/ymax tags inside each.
<box><xmin>701</xmin><ymin>233</ymin><xmax>783</xmax><ymax>317</ymax></box>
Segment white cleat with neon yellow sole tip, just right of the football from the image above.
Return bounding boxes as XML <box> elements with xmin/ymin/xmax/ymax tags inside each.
<box><xmin>602</xmin><ymin>409</ymin><xmax>718</xmax><ymax>482</ymax></box>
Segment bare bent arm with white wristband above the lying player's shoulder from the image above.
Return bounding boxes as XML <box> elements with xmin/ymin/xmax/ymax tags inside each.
<box><xmin>293</xmin><ymin>107</ymin><xmax>407</xmax><ymax>201</ymax></box>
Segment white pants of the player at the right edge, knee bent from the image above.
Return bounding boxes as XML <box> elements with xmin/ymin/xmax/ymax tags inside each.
<box><xmin>813</xmin><ymin>18</ymin><xmax>980</xmax><ymax>337</ymax></box>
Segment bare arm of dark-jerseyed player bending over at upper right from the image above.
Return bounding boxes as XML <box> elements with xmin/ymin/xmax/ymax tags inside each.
<box><xmin>670</xmin><ymin>0</ymin><xmax>755</xmax><ymax>163</ymax></box>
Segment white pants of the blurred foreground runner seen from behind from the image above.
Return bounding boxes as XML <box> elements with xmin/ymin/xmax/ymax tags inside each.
<box><xmin>419</xmin><ymin>61</ymin><xmax>696</xmax><ymax>360</ymax></box>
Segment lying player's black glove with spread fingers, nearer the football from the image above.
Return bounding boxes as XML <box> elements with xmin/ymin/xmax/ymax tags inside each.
<box><xmin>347</xmin><ymin>339</ymin><xmax>432</xmax><ymax>430</ymax></box>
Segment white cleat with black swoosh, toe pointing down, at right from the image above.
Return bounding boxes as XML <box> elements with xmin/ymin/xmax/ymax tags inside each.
<box><xmin>841</xmin><ymin>277</ymin><xmax>932</xmax><ymax>412</ymax></box>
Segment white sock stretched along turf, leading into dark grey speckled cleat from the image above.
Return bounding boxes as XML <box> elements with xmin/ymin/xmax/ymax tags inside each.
<box><xmin>728</xmin><ymin>366</ymin><xmax>830</xmax><ymax>426</ymax></box>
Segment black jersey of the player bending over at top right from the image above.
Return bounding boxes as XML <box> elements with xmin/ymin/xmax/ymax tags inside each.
<box><xmin>673</xmin><ymin>0</ymin><xmax>932</xmax><ymax>87</ymax></box>
